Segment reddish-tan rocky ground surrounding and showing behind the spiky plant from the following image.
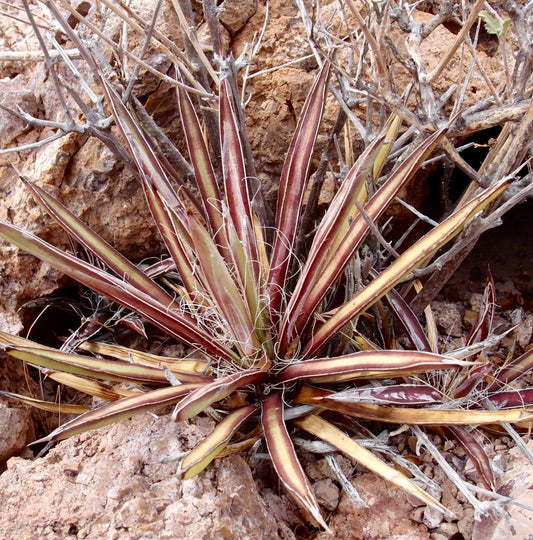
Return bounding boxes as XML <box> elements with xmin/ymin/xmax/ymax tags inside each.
<box><xmin>0</xmin><ymin>0</ymin><xmax>533</xmax><ymax>540</ymax></box>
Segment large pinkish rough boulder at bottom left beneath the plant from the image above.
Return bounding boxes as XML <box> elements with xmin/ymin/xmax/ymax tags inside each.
<box><xmin>0</xmin><ymin>415</ymin><xmax>294</xmax><ymax>540</ymax></box>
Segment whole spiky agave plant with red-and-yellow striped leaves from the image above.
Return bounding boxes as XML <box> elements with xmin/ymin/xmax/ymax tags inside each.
<box><xmin>0</xmin><ymin>0</ymin><xmax>533</xmax><ymax>529</ymax></box>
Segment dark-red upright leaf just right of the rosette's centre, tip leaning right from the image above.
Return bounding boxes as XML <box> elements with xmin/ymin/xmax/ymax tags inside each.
<box><xmin>267</xmin><ymin>61</ymin><xmax>330</xmax><ymax>313</ymax></box>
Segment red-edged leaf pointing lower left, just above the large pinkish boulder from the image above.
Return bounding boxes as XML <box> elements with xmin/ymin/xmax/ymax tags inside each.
<box><xmin>35</xmin><ymin>384</ymin><xmax>200</xmax><ymax>443</ymax></box>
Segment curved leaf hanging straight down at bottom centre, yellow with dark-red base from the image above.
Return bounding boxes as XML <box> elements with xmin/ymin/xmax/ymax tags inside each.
<box><xmin>261</xmin><ymin>392</ymin><xmax>329</xmax><ymax>532</ymax></box>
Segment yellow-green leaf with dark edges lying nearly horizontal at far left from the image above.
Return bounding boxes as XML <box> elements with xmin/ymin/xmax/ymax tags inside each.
<box><xmin>7</xmin><ymin>347</ymin><xmax>197</xmax><ymax>385</ymax></box>
